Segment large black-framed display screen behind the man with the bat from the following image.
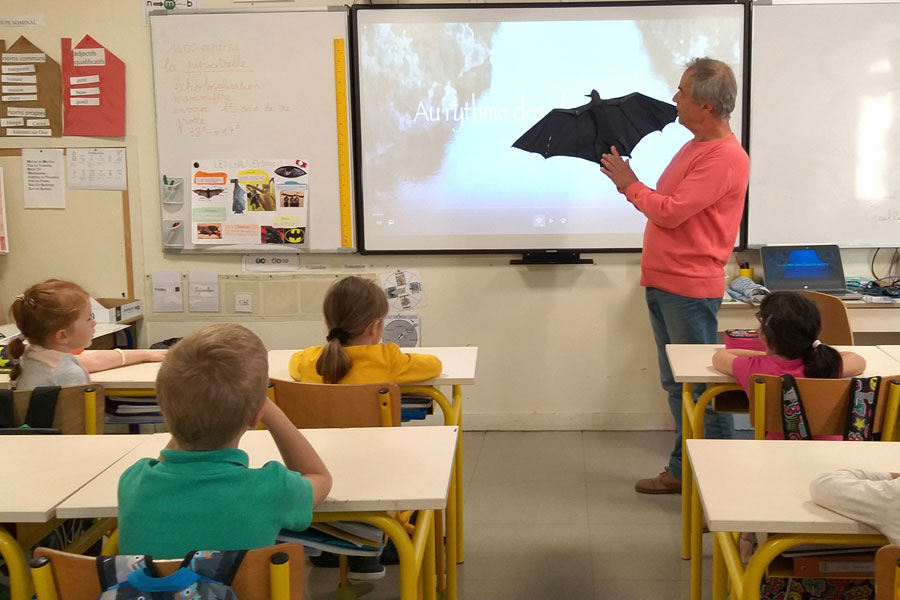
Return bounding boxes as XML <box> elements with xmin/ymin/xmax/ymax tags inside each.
<box><xmin>351</xmin><ymin>2</ymin><xmax>748</xmax><ymax>253</ymax></box>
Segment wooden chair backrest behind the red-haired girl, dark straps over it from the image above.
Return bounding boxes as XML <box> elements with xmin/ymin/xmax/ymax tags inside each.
<box><xmin>13</xmin><ymin>383</ymin><xmax>106</xmax><ymax>435</ymax></box>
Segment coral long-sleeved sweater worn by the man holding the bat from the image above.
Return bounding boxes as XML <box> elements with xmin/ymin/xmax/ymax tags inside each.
<box><xmin>625</xmin><ymin>134</ymin><xmax>750</xmax><ymax>298</ymax></box>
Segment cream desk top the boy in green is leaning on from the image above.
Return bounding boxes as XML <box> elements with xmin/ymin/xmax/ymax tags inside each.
<box><xmin>56</xmin><ymin>426</ymin><xmax>458</xmax><ymax>518</ymax></box>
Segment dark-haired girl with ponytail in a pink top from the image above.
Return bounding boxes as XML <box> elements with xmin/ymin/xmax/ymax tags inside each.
<box><xmin>713</xmin><ymin>292</ymin><xmax>866</xmax><ymax>395</ymax></box>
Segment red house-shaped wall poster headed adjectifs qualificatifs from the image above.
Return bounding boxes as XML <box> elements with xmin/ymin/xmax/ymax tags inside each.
<box><xmin>62</xmin><ymin>35</ymin><xmax>125</xmax><ymax>137</ymax></box>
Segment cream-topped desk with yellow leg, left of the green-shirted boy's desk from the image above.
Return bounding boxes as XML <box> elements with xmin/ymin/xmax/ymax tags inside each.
<box><xmin>0</xmin><ymin>435</ymin><xmax>147</xmax><ymax>600</ymax></box>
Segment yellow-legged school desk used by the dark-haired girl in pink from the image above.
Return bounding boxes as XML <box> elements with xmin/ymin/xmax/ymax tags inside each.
<box><xmin>666</xmin><ymin>344</ymin><xmax>900</xmax><ymax>600</ymax></box>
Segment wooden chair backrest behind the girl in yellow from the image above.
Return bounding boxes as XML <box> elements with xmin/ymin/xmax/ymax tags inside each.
<box><xmin>272</xmin><ymin>379</ymin><xmax>400</xmax><ymax>429</ymax></box>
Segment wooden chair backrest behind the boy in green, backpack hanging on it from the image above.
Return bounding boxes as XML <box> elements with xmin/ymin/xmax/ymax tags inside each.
<box><xmin>32</xmin><ymin>544</ymin><xmax>304</xmax><ymax>600</ymax></box>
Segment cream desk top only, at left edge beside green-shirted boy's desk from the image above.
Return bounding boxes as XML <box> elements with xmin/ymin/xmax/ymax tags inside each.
<box><xmin>0</xmin><ymin>435</ymin><xmax>147</xmax><ymax>523</ymax></box>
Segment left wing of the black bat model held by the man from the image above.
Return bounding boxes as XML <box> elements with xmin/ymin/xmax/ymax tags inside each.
<box><xmin>513</xmin><ymin>92</ymin><xmax>599</xmax><ymax>162</ymax></box>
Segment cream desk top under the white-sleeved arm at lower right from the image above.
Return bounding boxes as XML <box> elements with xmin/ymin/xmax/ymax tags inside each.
<box><xmin>687</xmin><ymin>439</ymin><xmax>900</xmax><ymax>534</ymax></box>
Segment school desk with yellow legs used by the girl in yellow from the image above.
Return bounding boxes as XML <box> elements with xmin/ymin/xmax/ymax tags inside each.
<box><xmin>269</xmin><ymin>346</ymin><xmax>478</xmax><ymax>592</ymax></box>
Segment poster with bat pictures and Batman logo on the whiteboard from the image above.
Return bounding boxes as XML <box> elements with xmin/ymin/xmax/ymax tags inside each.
<box><xmin>190</xmin><ymin>158</ymin><xmax>309</xmax><ymax>248</ymax></box>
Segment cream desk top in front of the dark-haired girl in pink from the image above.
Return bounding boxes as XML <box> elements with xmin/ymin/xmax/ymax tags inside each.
<box><xmin>666</xmin><ymin>344</ymin><xmax>900</xmax><ymax>383</ymax></box>
